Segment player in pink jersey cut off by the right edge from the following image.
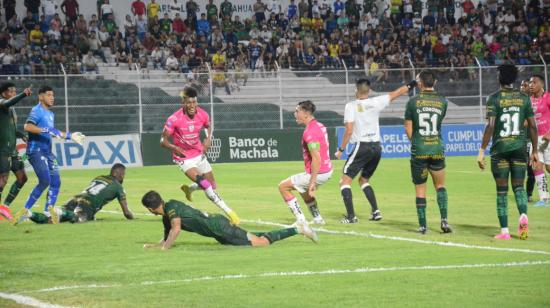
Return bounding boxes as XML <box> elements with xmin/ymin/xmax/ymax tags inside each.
<box><xmin>529</xmin><ymin>75</ymin><xmax>550</xmax><ymax>206</ymax></box>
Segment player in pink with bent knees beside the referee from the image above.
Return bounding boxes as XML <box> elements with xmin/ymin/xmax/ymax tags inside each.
<box><xmin>279</xmin><ymin>100</ymin><xmax>332</xmax><ymax>224</ymax></box>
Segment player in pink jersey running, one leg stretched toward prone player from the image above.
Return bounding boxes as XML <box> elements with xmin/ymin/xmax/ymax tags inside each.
<box><xmin>160</xmin><ymin>88</ymin><xmax>240</xmax><ymax>225</ymax></box>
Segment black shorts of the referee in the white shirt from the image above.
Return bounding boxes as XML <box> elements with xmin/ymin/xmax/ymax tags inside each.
<box><xmin>344</xmin><ymin>142</ymin><xmax>382</xmax><ymax>179</ymax></box>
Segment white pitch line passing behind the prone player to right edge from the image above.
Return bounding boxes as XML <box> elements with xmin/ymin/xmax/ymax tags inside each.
<box><xmin>101</xmin><ymin>211</ymin><xmax>550</xmax><ymax>255</ymax></box>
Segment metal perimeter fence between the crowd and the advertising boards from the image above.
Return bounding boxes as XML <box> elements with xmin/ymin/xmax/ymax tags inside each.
<box><xmin>0</xmin><ymin>60</ymin><xmax>548</xmax><ymax>135</ymax></box>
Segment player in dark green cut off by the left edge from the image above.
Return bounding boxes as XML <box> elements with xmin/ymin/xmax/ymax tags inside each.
<box><xmin>0</xmin><ymin>82</ymin><xmax>32</xmax><ymax>220</ymax></box>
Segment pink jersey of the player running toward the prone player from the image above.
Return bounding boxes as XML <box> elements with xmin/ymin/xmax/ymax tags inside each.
<box><xmin>164</xmin><ymin>107</ymin><xmax>210</xmax><ymax>160</ymax></box>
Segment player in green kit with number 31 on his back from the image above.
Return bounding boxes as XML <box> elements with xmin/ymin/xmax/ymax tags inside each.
<box><xmin>477</xmin><ymin>64</ymin><xmax>538</xmax><ymax>240</ymax></box>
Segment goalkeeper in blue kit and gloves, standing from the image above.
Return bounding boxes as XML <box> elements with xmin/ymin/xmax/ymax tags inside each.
<box><xmin>12</xmin><ymin>86</ymin><xmax>85</xmax><ymax>225</ymax></box>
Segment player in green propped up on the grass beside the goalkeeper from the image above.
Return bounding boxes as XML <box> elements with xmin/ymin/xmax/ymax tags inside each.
<box><xmin>24</xmin><ymin>163</ymin><xmax>134</xmax><ymax>224</ymax></box>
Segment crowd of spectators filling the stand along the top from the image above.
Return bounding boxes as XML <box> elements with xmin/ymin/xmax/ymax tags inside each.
<box><xmin>0</xmin><ymin>0</ymin><xmax>550</xmax><ymax>81</ymax></box>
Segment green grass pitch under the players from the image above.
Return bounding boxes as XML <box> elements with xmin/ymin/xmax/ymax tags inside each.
<box><xmin>0</xmin><ymin>157</ymin><xmax>550</xmax><ymax>307</ymax></box>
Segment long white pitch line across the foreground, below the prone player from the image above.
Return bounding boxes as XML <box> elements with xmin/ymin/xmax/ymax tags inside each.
<box><xmin>23</xmin><ymin>260</ymin><xmax>550</xmax><ymax>293</ymax></box>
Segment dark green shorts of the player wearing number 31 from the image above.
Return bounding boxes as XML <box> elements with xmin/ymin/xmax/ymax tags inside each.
<box><xmin>491</xmin><ymin>148</ymin><xmax>527</xmax><ymax>181</ymax></box>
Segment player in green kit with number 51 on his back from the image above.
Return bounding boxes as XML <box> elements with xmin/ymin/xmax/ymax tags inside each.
<box><xmin>405</xmin><ymin>71</ymin><xmax>453</xmax><ymax>234</ymax></box>
